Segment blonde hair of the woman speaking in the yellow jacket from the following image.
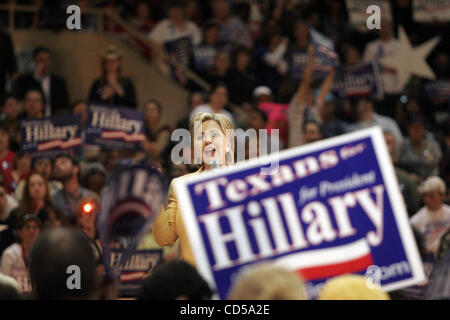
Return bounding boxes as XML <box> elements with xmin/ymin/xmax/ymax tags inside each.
<box><xmin>189</xmin><ymin>112</ymin><xmax>234</xmax><ymax>164</ymax></box>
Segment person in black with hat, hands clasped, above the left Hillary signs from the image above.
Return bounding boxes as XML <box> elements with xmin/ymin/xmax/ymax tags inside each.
<box><xmin>88</xmin><ymin>45</ymin><xmax>137</xmax><ymax>108</ymax></box>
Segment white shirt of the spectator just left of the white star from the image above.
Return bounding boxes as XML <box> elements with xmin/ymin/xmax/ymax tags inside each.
<box><xmin>363</xmin><ymin>39</ymin><xmax>403</xmax><ymax>94</ymax></box>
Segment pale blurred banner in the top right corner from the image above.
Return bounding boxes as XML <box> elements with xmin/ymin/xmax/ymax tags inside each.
<box><xmin>413</xmin><ymin>0</ymin><xmax>450</xmax><ymax>22</ymax></box>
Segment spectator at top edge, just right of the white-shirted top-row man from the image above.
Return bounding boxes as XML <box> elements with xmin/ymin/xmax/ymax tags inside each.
<box><xmin>212</xmin><ymin>0</ymin><xmax>252</xmax><ymax>48</ymax></box>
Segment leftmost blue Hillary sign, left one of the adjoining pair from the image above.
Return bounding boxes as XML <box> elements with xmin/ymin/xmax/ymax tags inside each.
<box><xmin>20</xmin><ymin>115</ymin><xmax>82</xmax><ymax>158</ymax></box>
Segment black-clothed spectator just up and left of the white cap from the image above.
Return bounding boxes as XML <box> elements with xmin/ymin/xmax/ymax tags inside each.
<box><xmin>229</xmin><ymin>47</ymin><xmax>255</xmax><ymax>106</ymax></box>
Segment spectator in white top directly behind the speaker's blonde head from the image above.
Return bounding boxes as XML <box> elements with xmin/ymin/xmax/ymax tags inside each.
<box><xmin>189</xmin><ymin>83</ymin><xmax>234</xmax><ymax>125</ymax></box>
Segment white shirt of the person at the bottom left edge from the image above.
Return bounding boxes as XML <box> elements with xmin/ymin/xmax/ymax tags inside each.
<box><xmin>0</xmin><ymin>243</ymin><xmax>32</xmax><ymax>292</ymax></box>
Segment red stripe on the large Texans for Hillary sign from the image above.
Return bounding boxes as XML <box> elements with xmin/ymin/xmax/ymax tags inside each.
<box><xmin>297</xmin><ymin>253</ymin><xmax>373</xmax><ymax>281</ymax></box>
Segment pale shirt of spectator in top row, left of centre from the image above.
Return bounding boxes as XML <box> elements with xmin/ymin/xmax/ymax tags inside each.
<box><xmin>149</xmin><ymin>19</ymin><xmax>202</xmax><ymax>45</ymax></box>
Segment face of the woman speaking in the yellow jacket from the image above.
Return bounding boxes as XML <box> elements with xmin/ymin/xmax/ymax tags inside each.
<box><xmin>195</xmin><ymin>120</ymin><xmax>227</xmax><ymax>167</ymax></box>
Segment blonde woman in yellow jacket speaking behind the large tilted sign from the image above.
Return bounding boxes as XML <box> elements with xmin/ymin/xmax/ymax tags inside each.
<box><xmin>152</xmin><ymin>112</ymin><xmax>234</xmax><ymax>265</ymax></box>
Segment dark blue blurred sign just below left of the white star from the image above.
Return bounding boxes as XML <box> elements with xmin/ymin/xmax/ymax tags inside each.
<box><xmin>332</xmin><ymin>62</ymin><xmax>384</xmax><ymax>99</ymax></box>
